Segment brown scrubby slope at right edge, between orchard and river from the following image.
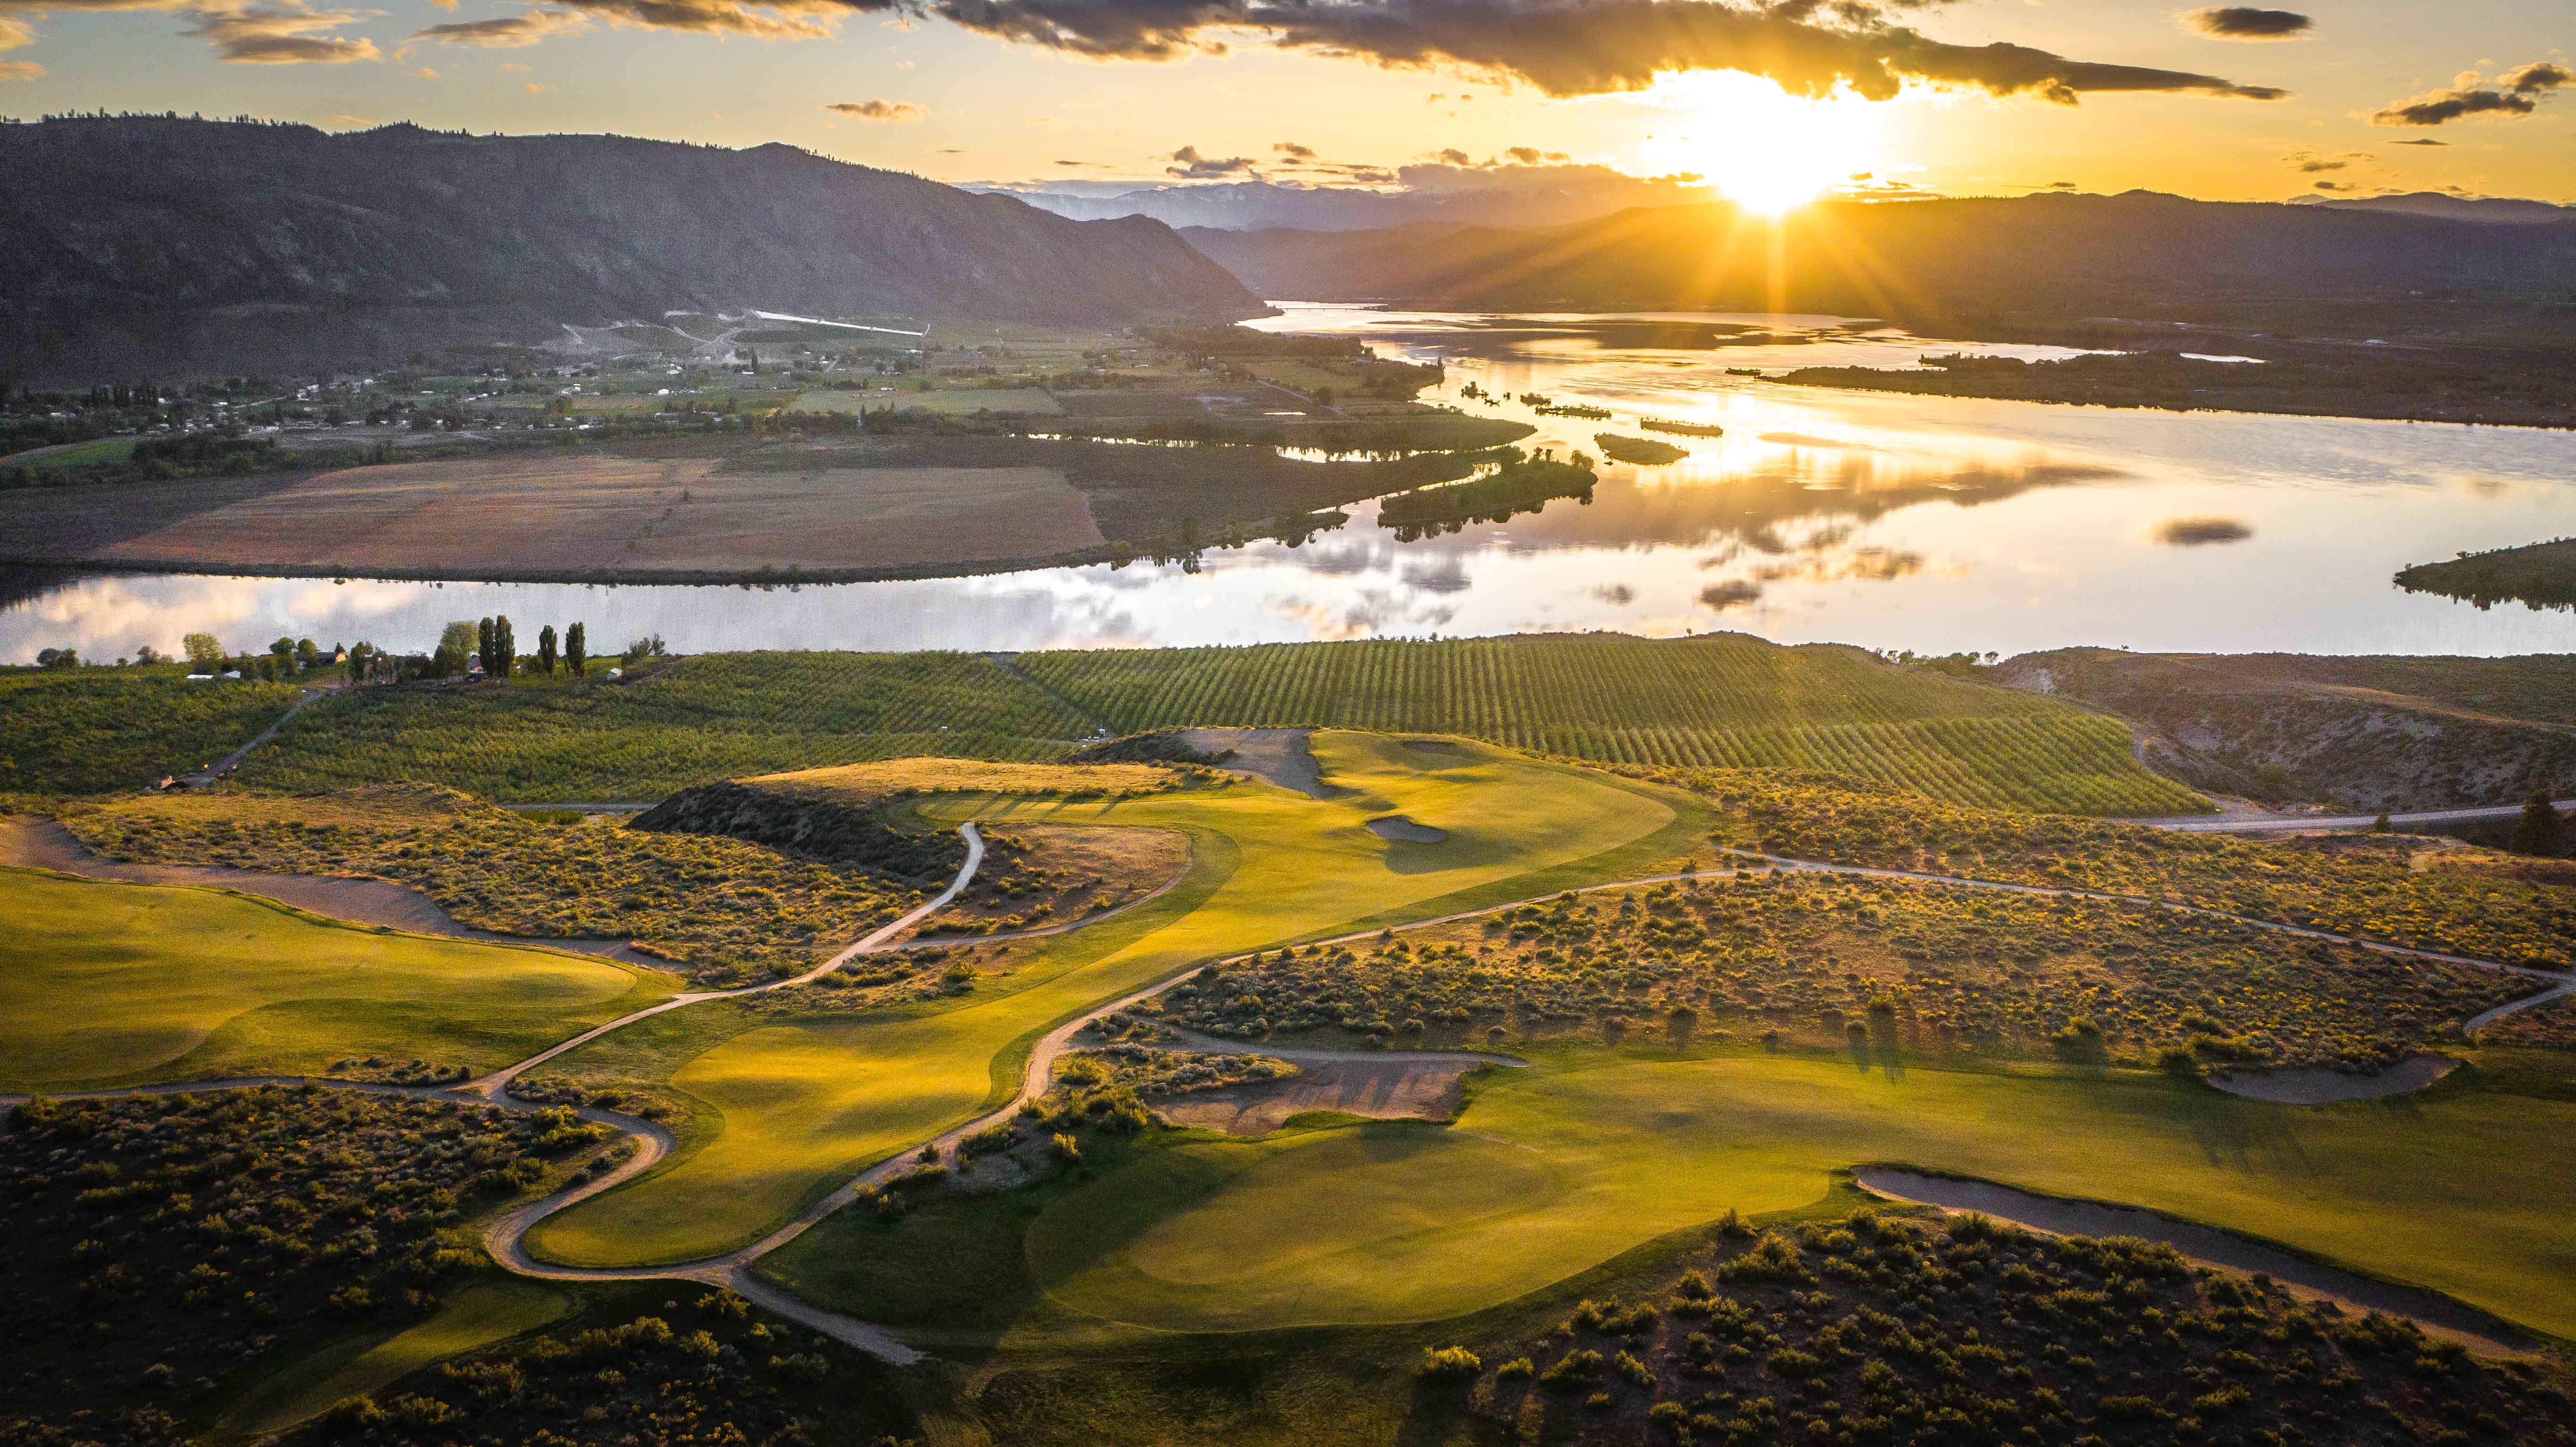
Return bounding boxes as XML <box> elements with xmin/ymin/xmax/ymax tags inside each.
<box><xmin>1999</xmin><ymin>649</ymin><xmax>2576</xmax><ymax>808</ymax></box>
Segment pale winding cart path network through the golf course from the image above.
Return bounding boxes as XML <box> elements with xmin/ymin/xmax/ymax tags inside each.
<box><xmin>15</xmin><ymin>824</ymin><xmax>2576</xmax><ymax>1365</ymax></box>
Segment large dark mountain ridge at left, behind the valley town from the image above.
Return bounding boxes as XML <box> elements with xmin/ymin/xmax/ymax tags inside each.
<box><xmin>0</xmin><ymin>116</ymin><xmax>1262</xmax><ymax>384</ymax></box>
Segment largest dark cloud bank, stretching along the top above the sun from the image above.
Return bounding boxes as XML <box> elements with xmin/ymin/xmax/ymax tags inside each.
<box><xmin>917</xmin><ymin>0</ymin><xmax>2285</xmax><ymax>106</ymax></box>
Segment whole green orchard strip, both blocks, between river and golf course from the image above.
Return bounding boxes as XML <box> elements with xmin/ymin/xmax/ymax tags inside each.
<box><xmin>206</xmin><ymin>636</ymin><xmax>2205</xmax><ymax>816</ymax></box>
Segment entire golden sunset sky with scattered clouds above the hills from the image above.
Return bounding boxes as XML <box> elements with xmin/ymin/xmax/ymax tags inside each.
<box><xmin>0</xmin><ymin>0</ymin><xmax>2576</xmax><ymax>206</ymax></box>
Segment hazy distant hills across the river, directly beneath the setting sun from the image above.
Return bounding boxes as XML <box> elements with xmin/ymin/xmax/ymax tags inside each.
<box><xmin>1182</xmin><ymin>193</ymin><xmax>2576</xmax><ymax>337</ymax></box>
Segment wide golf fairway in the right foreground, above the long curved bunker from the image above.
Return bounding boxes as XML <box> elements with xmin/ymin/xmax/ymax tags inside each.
<box><xmin>1028</xmin><ymin>1056</ymin><xmax>2576</xmax><ymax>1336</ymax></box>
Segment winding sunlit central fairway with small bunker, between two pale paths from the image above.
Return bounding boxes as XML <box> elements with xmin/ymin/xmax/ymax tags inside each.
<box><xmin>512</xmin><ymin>734</ymin><xmax>1703</xmax><ymax>1267</ymax></box>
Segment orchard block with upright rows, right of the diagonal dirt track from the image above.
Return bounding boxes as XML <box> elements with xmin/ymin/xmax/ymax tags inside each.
<box><xmin>1017</xmin><ymin>633</ymin><xmax>2208</xmax><ymax>814</ymax></box>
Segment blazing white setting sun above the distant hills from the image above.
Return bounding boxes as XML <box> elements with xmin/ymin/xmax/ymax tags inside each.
<box><xmin>1638</xmin><ymin>69</ymin><xmax>1878</xmax><ymax>216</ymax></box>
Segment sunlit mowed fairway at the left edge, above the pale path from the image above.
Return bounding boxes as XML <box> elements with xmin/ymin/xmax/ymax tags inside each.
<box><xmin>0</xmin><ymin>870</ymin><xmax>675</xmax><ymax>1092</ymax></box>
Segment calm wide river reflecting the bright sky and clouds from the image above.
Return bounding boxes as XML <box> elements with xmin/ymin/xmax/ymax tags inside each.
<box><xmin>0</xmin><ymin>306</ymin><xmax>2576</xmax><ymax>662</ymax></box>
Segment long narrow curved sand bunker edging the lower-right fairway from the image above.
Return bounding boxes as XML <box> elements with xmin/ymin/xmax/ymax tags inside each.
<box><xmin>1852</xmin><ymin>1167</ymin><xmax>2532</xmax><ymax>1352</ymax></box>
